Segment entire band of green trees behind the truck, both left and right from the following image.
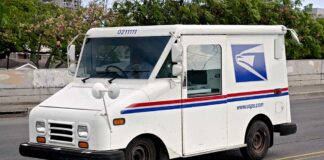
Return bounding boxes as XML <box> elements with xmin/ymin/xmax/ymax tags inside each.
<box><xmin>0</xmin><ymin>0</ymin><xmax>324</xmax><ymax>67</ymax></box>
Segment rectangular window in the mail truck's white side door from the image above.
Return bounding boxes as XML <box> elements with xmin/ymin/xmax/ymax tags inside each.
<box><xmin>187</xmin><ymin>44</ymin><xmax>222</xmax><ymax>97</ymax></box>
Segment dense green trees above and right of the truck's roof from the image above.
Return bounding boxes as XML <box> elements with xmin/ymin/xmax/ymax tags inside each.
<box><xmin>111</xmin><ymin>0</ymin><xmax>324</xmax><ymax>59</ymax></box>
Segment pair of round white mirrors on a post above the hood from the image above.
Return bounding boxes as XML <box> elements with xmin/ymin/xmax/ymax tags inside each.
<box><xmin>91</xmin><ymin>83</ymin><xmax>120</xmax><ymax>99</ymax></box>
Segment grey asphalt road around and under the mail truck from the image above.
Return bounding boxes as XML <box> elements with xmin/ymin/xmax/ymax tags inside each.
<box><xmin>0</xmin><ymin>99</ymin><xmax>324</xmax><ymax>160</ymax></box>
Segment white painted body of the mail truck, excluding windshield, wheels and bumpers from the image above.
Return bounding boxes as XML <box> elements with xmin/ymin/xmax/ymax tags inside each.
<box><xmin>29</xmin><ymin>25</ymin><xmax>291</xmax><ymax>159</ymax></box>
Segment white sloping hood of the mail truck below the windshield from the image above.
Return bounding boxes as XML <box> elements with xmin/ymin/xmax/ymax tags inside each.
<box><xmin>39</xmin><ymin>80</ymin><xmax>170</xmax><ymax>111</ymax></box>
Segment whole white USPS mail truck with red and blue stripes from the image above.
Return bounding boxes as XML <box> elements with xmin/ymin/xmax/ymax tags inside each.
<box><xmin>20</xmin><ymin>25</ymin><xmax>297</xmax><ymax>160</ymax></box>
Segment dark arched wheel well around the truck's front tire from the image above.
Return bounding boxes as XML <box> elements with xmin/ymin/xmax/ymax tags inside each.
<box><xmin>128</xmin><ymin>134</ymin><xmax>169</xmax><ymax>160</ymax></box>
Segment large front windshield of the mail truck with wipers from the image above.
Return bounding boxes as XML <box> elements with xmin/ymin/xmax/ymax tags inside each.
<box><xmin>77</xmin><ymin>36</ymin><xmax>170</xmax><ymax>79</ymax></box>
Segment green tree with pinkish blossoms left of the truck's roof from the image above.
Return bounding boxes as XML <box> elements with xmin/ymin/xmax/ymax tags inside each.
<box><xmin>0</xmin><ymin>0</ymin><xmax>108</xmax><ymax>68</ymax></box>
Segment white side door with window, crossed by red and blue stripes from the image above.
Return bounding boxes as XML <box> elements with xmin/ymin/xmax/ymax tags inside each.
<box><xmin>181</xmin><ymin>35</ymin><xmax>227</xmax><ymax>156</ymax></box>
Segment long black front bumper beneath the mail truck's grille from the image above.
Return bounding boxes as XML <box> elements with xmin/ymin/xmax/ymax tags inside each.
<box><xmin>19</xmin><ymin>143</ymin><xmax>125</xmax><ymax>160</ymax></box>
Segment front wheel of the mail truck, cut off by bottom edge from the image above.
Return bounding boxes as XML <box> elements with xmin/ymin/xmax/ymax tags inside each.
<box><xmin>125</xmin><ymin>138</ymin><xmax>157</xmax><ymax>160</ymax></box>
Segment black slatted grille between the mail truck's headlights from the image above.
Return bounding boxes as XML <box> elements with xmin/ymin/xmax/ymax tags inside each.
<box><xmin>50</xmin><ymin>123</ymin><xmax>74</xmax><ymax>142</ymax></box>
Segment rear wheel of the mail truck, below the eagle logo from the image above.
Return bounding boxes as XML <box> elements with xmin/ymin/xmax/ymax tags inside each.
<box><xmin>240</xmin><ymin>121</ymin><xmax>270</xmax><ymax>160</ymax></box>
